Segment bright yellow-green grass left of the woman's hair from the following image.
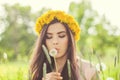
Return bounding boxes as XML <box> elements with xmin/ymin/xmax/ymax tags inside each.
<box><xmin>0</xmin><ymin>62</ymin><xmax>28</xmax><ymax>80</ymax></box>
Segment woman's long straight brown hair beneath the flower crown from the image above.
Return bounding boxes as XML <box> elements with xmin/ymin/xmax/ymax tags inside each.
<box><xmin>30</xmin><ymin>18</ymin><xmax>79</xmax><ymax>80</ymax></box>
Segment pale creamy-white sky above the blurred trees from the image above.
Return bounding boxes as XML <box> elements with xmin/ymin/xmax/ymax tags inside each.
<box><xmin>0</xmin><ymin>0</ymin><xmax>120</xmax><ymax>34</ymax></box>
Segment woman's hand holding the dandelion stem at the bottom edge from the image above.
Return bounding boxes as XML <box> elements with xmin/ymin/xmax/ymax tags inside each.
<box><xmin>42</xmin><ymin>72</ymin><xmax>63</xmax><ymax>80</ymax></box>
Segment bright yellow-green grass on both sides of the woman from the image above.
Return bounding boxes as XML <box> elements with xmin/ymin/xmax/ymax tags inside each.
<box><xmin>0</xmin><ymin>56</ymin><xmax>120</xmax><ymax>80</ymax></box>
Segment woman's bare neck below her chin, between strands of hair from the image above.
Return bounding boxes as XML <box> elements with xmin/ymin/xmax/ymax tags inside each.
<box><xmin>56</xmin><ymin>55</ymin><xmax>67</xmax><ymax>73</ymax></box>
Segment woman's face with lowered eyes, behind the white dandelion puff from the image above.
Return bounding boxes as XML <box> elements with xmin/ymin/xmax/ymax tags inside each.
<box><xmin>45</xmin><ymin>22</ymin><xmax>68</xmax><ymax>58</ymax></box>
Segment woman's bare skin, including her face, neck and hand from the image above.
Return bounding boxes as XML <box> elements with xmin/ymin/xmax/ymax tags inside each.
<box><xmin>45</xmin><ymin>22</ymin><xmax>68</xmax><ymax>80</ymax></box>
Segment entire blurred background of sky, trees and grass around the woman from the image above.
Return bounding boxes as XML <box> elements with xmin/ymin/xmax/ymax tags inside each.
<box><xmin>0</xmin><ymin>0</ymin><xmax>120</xmax><ymax>80</ymax></box>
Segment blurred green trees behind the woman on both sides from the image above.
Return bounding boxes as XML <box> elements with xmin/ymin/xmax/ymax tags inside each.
<box><xmin>0</xmin><ymin>1</ymin><xmax>120</xmax><ymax>60</ymax></box>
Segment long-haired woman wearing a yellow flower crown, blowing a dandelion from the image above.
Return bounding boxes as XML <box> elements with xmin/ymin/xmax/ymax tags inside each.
<box><xmin>30</xmin><ymin>11</ymin><xmax>97</xmax><ymax>80</ymax></box>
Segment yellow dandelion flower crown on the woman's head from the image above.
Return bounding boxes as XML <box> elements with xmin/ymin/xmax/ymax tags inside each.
<box><xmin>35</xmin><ymin>10</ymin><xmax>80</xmax><ymax>41</ymax></box>
